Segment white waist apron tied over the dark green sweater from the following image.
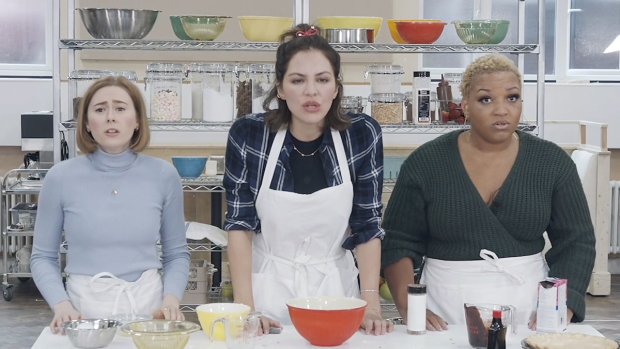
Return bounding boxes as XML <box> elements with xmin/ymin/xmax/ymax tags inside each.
<box><xmin>420</xmin><ymin>249</ymin><xmax>548</xmax><ymax>325</ymax></box>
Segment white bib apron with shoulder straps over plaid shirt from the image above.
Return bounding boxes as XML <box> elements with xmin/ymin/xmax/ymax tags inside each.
<box><xmin>252</xmin><ymin>129</ymin><xmax>359</xmax><ymax>324</ymax></box>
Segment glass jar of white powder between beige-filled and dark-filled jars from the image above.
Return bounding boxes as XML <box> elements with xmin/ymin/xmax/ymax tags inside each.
<box><xmin>202</xmin><ymin>63</ymin><xmax>236</xmax><ymax>122</ymax></box>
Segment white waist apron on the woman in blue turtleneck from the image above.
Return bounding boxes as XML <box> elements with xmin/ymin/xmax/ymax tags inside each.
<box><xmin>67</xmin><ymin>269</ymin><xmax>163</xmax><ymax>319</ymax></box>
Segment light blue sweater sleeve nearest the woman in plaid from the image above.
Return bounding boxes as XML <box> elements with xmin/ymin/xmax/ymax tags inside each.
<box><xmin>160</xmin><ymin>166</ymin><xmax>190</xmax><ymax>300</ymax></box>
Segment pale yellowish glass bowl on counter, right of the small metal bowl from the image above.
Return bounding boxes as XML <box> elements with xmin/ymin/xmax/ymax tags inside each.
<box><xmin>121</xmin><ymin>320</ymin><xmax>200</xmax><ymax>349</ymax></box>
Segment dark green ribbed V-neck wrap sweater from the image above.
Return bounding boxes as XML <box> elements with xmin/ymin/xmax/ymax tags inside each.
<box><xmin>381</xmin><ymin>131</ymin><xmax>595</xmax><ymax>322</ymax></box>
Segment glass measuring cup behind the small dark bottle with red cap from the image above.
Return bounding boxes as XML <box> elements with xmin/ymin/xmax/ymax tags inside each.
<box><xmin>464</xmin><ymin>303</ymin><xmax>517</xmax><ymax>349</ymax></box>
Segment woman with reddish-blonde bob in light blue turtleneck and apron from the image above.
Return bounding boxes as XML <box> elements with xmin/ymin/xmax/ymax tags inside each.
<box><xmin>31</xmin><ymin>77</ymin><xmax>189</xmax><ymax>333</ymax></box>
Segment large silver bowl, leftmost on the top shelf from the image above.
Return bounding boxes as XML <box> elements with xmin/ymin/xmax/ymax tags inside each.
<box><xmin>76</xmin><ymin>8</ymin><xmax>160</xmax><ymax>39</ymax></box>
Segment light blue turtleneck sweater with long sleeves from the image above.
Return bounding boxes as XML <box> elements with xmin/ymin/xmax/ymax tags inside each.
<box><xmin>31</xmin><ymin>150</ymin><xmax>189</xmax><ymax>307</ymax></box>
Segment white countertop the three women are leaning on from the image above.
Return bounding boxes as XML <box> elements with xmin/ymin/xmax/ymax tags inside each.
<box><xmin>32</xmin><ymin>325</ymin><xmax>602</xmax><ymax>349</ymax></box>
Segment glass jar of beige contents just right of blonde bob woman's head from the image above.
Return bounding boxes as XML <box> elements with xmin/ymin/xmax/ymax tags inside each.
<box><xmin>144</xmin><ymin>63</ymin><xmax>185</xmax><ymax>121</ymax></box>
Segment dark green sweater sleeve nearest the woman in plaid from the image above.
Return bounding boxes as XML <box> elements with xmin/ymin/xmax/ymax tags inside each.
<box><xmin>381</xmin><ymin>159</ymin><xmax>428</xmax><ymax>271</ymax></box>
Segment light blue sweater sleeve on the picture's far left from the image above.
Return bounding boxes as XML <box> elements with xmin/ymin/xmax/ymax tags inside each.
<box><xmin>30</xmin><ymin>166</ymin><xmax>69</xmax><ymax>308</ymax></box>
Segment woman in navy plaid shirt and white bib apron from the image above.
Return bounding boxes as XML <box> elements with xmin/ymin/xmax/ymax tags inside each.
<box><xmin>224</xmin><ymin>24</ymin><xmax>393</xmax><ymax>335</ymax></box>
